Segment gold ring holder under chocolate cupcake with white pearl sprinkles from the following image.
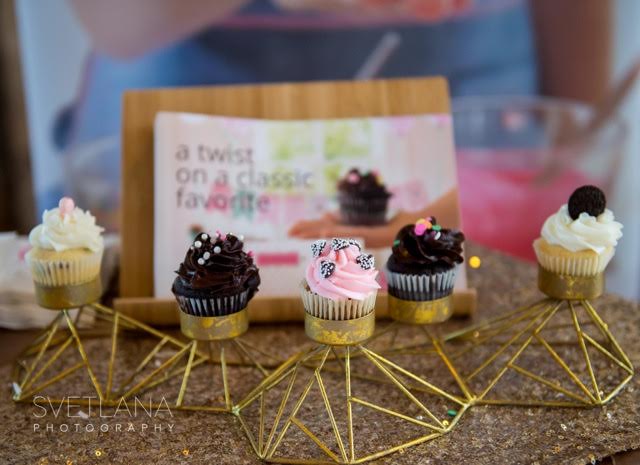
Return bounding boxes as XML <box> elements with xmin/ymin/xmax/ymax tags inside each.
<box><xmin>179</xmin><ymin>308</ymin><xmax>249</xmax><ymax>341</ymax></box>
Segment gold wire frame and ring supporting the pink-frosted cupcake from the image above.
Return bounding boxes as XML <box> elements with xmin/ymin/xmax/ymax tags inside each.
<box><xmin>233</xmin><ymin>312</ymin><xmax>470</xmax><ymax>464</ymax></box>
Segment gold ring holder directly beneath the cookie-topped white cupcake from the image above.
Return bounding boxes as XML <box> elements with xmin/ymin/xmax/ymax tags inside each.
<box><xmin>538</xmin><ymin>266</ymin><xmax>605</xmax><ymax>300</ymax></box>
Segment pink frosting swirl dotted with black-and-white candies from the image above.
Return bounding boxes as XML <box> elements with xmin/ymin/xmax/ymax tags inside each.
<box><xmin>306</xmin><ymin>239</ymin><xmax>380</xmax><ymax>300</ymax></box>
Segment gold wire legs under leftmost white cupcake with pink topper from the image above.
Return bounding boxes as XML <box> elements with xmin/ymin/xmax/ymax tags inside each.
<box><xmin>12</xmin><ymin>300</ymin><xmax>185</xmax><ymax>405</ymax></box>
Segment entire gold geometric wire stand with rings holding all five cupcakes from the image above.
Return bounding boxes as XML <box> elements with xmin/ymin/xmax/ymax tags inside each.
<box><xmin>12</xmin><ymin>268</ymin><xmax>634</xmax><ymax>464</ymax></box>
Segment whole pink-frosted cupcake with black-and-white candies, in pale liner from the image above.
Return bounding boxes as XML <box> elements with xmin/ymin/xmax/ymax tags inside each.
<box><xmin>302</xmin><ymin>238</ymin><xmax>380</xmax><ymax>320</ymax></box>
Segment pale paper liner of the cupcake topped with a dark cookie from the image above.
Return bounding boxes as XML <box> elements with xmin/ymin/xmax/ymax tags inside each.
<box><xmin>533</xmin><ymin>239</ymin><xmax>615</xmax><ymax>276</ymax></box>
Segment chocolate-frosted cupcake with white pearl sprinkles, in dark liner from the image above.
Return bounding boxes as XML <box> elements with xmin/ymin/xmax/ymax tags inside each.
<box><xmin>171</xmin><ymin>233</ymin><xmax>260</xmax><ymax>317</ymax></box>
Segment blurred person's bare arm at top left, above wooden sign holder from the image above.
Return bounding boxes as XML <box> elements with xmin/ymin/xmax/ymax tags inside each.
<box><xmin>70</xmin><ymin>0</ymin><xmax>248</xmax><ymax>58</ymax></box>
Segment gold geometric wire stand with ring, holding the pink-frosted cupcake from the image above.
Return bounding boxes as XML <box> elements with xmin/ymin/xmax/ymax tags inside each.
<box><xmin>233</xmin><ymin>313</ymin><xmax>468</xmax><ymax>464</ymax></box>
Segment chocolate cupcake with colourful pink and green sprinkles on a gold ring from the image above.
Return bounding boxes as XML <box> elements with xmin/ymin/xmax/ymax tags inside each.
<box><xmin>387</xmin><ymin>216</ymin><xmax>464</xmax><ymax>301</ymax></box>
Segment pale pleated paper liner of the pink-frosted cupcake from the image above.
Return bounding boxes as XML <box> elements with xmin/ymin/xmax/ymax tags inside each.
<box><xmin>301</xmin><ymin>282</ymin><xmax>377</xmax><ymax>321</ymax></box>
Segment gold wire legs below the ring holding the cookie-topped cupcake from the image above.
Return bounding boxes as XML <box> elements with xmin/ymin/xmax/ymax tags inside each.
<box><xmin>446</xmin><ymin>298</ymin><xmax>634</xmax><ymax>407</ymax></box>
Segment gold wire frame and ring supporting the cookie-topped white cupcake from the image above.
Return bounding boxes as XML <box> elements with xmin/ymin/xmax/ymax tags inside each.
<box><xmin>445</xmin><ymin>267</ymin><xmax>634</xmax><ymax>407</ymax></box>
